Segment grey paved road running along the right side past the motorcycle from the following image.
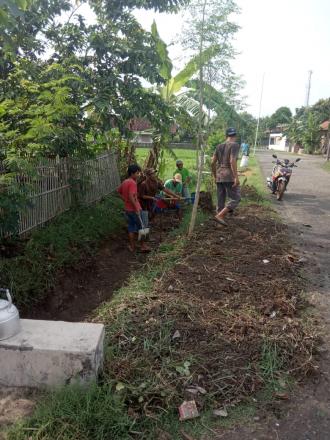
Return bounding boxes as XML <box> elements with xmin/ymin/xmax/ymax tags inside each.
<box><xmin>221</xmin><ymin>152</ymin><xmax>330</xmax><ymax>440</ymax></box>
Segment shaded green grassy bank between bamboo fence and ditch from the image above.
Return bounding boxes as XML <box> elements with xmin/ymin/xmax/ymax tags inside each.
<box><xmin>0</xmin><ymin>196</ymin><xmax>124</xmax><ymax>306</ymax></box>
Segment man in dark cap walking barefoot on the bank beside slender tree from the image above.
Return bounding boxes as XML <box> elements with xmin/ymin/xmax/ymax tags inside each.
<box><xmin>212</xmin><ymin>128</ymin><xmax>241</xmax><ymax>226</ymax></box>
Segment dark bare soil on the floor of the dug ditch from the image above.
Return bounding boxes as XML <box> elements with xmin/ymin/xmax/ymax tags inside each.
<box><xmin>20</xmin><ymin>214</ymin><xmax>183</xmax><ymax>322</ymax></box>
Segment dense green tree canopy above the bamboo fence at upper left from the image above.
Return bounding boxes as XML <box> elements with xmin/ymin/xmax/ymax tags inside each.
<box><xmin>0</xmin><ymin>0</ymin><xmax>186</xmax><ymax>162</ymax></box>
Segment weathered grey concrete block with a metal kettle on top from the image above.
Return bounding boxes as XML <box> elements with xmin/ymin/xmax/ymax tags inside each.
<box><xmin>0</xmin><ymin>319</ymin><xmax>104</xmax><ymax>388</ymax></box>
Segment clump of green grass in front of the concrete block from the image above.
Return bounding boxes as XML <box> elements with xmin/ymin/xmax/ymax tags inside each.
<box><xmin>7</xmin><ymin>383</ymin><xmax>134</xmax><ymax>440</ymax></box>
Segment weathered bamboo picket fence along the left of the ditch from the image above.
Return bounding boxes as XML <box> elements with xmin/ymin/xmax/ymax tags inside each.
<box><xmin>10</xmin><ymin>152</ymin><xmax>120</xmax><ymax>234</ymax></box>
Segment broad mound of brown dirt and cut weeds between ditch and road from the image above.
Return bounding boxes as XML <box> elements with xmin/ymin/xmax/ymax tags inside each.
<box><xmin>104</xmin><ymin>206</ymin><xmax>318</xmax><ymax>415</ymax></box>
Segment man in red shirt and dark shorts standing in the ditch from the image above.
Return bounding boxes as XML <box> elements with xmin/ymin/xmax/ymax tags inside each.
<box><xmin>117</xmin><ymin>165</ymin><xmax>150</xmax><ymax>252</ymax></box>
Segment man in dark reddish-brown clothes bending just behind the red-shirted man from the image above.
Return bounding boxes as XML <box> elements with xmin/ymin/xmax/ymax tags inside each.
<box><xmin>138</xmin><ymin>168</ymin><xmax>178</xmax><ymax>220</ymax></box>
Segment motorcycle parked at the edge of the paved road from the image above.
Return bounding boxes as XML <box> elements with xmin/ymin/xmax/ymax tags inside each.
<box><xmin>267</xmin><ymin>154</ymin><xmax>300</xmax><ymax>201</ymax></box>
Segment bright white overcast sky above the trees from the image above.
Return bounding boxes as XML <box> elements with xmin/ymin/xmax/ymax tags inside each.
<box><xmin>136</xmin><ymin>0</ymin><xmax>330</xmax><ymax>116</ymax></box>
